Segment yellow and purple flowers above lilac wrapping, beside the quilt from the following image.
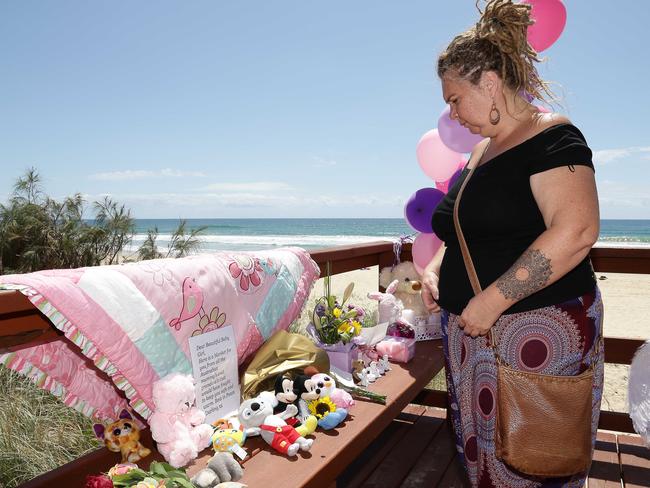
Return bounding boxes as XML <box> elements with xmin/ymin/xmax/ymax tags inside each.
<box><xmin>312</xmin><ymin>276</ymin><xmax>366</xmax><ymax>345</ymax></box>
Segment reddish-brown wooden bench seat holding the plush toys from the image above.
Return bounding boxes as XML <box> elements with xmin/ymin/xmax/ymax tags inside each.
<box><xmin>23</xmin><ymin>341</ymin><xmax>444</xmax><ymax>488</ymax></box>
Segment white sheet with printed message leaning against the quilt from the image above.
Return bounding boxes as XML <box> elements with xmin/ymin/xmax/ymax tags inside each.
<box><xmin>189</xmin><ymin>326</ymin><xmax>239</xmax><ymax>423</ymax></box>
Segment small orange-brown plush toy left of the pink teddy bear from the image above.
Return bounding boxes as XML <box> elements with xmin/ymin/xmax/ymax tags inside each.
<box><xmin>93</xmin><ymin>409</ymin><xmax>151</xmax><ymax>463</ymax></box>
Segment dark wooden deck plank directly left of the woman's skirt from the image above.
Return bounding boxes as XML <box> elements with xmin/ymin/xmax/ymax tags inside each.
<box><xmin>402</xmin><ymin>409</ymin><xmax>456</xmax><ymax>488</ymax></box>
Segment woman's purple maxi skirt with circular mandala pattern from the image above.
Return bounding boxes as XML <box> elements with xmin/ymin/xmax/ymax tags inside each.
<box><xmin>442</xmin><ymin>287</ymin><xmax>603</xmax><ymax>488</ymax></box>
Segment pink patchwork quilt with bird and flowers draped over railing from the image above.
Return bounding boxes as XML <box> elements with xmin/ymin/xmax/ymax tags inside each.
<box><xmin>0</xmin><ymin>248</ymin><xmax>319</xmax><ymax>420</ymax></box>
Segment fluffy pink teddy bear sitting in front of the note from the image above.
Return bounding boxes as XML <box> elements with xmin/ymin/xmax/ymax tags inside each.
<box><xmin>149</xmin><ymin>373</ymin><xmax>213</xmax><ymax>468</ymax></box>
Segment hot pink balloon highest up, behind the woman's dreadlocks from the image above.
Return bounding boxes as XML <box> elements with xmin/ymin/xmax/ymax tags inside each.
<box><xmin>522</xmin><ymin>0</ymin><xmax>566</xmax><ymax>52</ymax></box>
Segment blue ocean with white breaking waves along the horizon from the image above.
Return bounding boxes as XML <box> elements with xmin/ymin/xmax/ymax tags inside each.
<box><xmin>125</xmin><ymin>219</ymin><xmax>650</xmax><ymax>253</ymax></box>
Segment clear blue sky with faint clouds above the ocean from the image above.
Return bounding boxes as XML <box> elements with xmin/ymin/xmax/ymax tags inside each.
<box><xmin>0</xmin><ymin>0</ymin><xmax>650</xmax><ymax>219</ymax></box>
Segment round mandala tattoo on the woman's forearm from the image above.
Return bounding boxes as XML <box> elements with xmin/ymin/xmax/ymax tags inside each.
<box><xmin>496</xmin><ymin>249</ymin><xmax>551</xmax><ymax>301</ymax></box>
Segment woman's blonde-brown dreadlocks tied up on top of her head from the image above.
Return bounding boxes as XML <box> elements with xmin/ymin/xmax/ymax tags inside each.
<box><xmin>438</xmin><ymin>0</ymin><xmax>556</xmax><ymax>102</ymax></box>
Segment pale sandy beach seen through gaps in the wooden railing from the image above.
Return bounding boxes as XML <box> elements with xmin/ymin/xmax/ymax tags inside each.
<box><xmin>299</xmin><ymin>266</ymin><xmax>650</xmax><ymax>412</ymax></box>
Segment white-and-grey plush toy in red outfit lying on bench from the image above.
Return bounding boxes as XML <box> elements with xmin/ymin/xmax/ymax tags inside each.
<box><xmin>237</xmin><ymin>392</ymin><xmax>314</xmax><ymax>457</ymax></box>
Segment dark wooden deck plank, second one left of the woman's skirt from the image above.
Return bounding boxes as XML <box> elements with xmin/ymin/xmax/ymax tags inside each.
<box><xmin>361</xmin><ymin>406</ymin><xmax>444</xmax><ymax>488</ymax></box>
